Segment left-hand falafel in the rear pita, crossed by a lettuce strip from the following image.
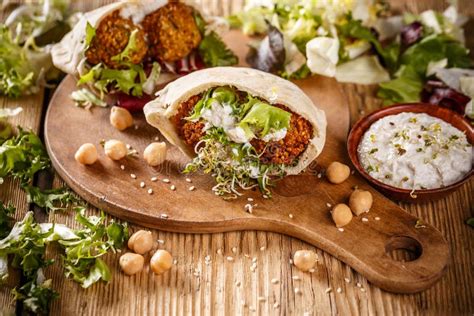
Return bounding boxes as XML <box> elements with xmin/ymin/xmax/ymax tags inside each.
<box><xmin>85</xmin><ymin>10</ymin><xmax>148</xmax><ymax>69</ymax></box>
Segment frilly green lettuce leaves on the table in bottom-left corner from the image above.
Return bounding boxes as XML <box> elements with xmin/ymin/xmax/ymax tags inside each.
<box><xmin>0</xmin><ymin>203</ymin><xmax>128</xmax><ymax>315</ymax></box>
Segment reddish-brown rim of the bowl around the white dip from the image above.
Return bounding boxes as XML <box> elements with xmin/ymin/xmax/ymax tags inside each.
<box><xmin>346</xmin><ymin>102</ymin><xmax>474</xmax><ymax>196</ymax></box>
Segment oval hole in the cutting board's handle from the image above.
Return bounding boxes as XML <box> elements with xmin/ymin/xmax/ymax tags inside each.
<box><xmin>385</xmin><ymin>236</ymin><xmax>423</xmax><ymax>262</ymax></box>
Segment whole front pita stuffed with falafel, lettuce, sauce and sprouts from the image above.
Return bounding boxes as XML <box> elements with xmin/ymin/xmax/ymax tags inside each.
<box><xmin>144</xmin><ymin>67</ymin><xmax>327</xmax><ymax>196</ymax></box>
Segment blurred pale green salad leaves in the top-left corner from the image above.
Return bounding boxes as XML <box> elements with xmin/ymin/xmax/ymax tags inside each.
<box><xmin>0</xmin><ymin>0</ymin><xmax>69</xmax><ymax>97</ymax></box>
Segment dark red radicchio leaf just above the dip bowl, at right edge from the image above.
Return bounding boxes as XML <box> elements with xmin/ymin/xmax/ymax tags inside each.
<box><xmin>421</xmin><ymin>80</ymin><xmax>471</xmax><ymax>115</ymax></box>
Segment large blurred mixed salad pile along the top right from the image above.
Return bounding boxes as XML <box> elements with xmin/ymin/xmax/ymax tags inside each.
<box><xmin>229</xmin><ymin>0</ymin><xmax>474</xmax><ymax>118</ymax></box>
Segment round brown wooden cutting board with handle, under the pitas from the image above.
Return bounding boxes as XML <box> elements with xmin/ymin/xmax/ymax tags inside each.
<box><xmin>45</xmin><ymin>32</ymin><xmax>449</xmax><ymax>293</ymax></box>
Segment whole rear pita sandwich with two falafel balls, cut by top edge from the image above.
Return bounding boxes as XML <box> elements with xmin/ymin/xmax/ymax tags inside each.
<box><xmin>52</xmin><ymin>0</ymin><xmax>237</xmax><ymax>110</ymax></box>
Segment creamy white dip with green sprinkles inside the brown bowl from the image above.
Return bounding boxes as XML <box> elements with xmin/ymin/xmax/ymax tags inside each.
<box><xmin>357</xmin><ymin>112</ymin><xmax>473</xmax><ymax>190</ymax></box>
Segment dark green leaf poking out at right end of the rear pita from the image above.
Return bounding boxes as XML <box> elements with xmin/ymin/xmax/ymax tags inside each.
<box><xmin>198</xmin><ymin>32</ymin><xmax>239</xmax><ymax>67</ymax></box>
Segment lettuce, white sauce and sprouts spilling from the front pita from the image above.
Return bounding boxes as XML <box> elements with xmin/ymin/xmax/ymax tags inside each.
<box><xmin>184</xmin><ymin>87</ymin><xmax>291</xmax><ymax>198</ymax></box>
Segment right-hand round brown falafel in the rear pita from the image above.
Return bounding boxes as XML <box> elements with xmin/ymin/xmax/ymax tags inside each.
<box><xmin>142</xmin><ymin>2</ymin><xmax>201</xmax><ymax>62</ymax></box>
